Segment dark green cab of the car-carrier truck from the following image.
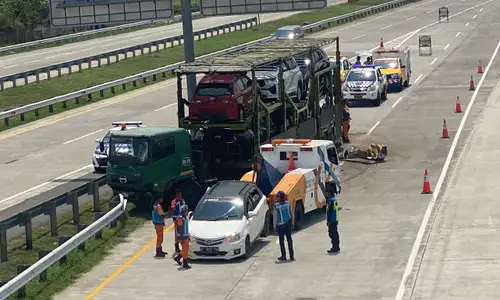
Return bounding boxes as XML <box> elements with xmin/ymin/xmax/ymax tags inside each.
<box><xmin>107</xmin><ymin>126</ymin><xmax>205</xmax><ymax>206</ymax></box>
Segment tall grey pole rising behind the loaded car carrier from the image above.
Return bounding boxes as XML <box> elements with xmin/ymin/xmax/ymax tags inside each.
<box><xmin>182</xmin><ymin>0</ymin><xmax>196</xmax><ymax>101</ymax></box>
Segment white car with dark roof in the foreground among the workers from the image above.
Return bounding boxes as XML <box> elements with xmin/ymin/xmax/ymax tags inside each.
<box><xmin>189</xmin><ymin>180</ymin><xmax>270</xmax><ymax>260</ymax></box>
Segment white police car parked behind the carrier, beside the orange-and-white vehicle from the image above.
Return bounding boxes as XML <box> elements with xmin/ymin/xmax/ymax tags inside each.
<box><xmin>342</xmin><ymin>65</ymin><xmax>387</xmax><ymax>106</ymax></box>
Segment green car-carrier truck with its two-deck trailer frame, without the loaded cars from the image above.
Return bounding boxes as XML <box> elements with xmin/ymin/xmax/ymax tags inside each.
<box><xmin>107</xmin><ymin>38</ymin><xmax>340</xmax><ymax>207</ymax></box>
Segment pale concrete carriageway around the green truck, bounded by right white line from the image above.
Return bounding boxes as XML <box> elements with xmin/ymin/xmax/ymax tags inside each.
<box><xmin>0</xmin><ymin>0</ymin><xmax>499</xmax><ymax>299</ymax></box>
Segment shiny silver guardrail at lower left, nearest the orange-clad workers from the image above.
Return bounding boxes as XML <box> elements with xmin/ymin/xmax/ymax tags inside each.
<box><xmin>0</xmin><ymin>194</ymin><xmax>127</xmax><ymax>299</ymax></box>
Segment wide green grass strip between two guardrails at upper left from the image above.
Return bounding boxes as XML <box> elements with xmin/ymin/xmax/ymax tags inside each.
<box><xmin>0</xmin><ymin>0</ymin><xmax>398</xmax><ymax>131</ymax></box>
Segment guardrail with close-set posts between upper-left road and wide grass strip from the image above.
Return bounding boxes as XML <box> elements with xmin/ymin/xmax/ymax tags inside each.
<box><xmin>0</xmin><ymin>17</ymin><xmax>258</xmax><ymax>91</ymax></box>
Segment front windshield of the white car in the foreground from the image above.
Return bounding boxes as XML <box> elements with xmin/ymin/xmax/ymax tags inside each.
<box><xmin>193</xmin><ymin>198</ymin><xmax>244</xmax><ymax>221</ymax></box>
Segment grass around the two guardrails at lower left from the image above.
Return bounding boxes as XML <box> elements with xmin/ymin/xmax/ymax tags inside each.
<box><xmin>0</xmin><ymin>196</ymin><xmax>146</xmax><ymax>300</ymax></box>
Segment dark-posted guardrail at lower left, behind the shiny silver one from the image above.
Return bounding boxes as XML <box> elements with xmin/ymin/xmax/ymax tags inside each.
<box><xmin>0</xmin><ymin>175</ymin><xmax>107</xmax><ymax>262</ymax></box>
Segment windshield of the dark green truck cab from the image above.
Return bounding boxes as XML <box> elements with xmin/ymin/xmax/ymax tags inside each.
<box><xmin>109</xmin><ymin>136</ymin><xmax>149</xmax><ymax>165</ymax></box>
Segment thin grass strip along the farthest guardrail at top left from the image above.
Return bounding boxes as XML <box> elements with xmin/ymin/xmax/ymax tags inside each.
<box><xmin>0</xmin><ymin>0</ymin><xmax>200</xmax><ymax>57</ymax></box>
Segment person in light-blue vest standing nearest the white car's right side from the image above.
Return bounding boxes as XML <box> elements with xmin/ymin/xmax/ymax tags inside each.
<box><xmin>273</xmin><ymin>191</ymin><xmax>295</xmax><ymax>261</ymax></box>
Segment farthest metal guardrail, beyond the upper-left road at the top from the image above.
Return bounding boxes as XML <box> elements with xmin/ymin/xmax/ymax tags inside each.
<box><xmin>0</xmin><ymin>12</ymin><xmax>201</xmax><ymax>53</ymax></box>
